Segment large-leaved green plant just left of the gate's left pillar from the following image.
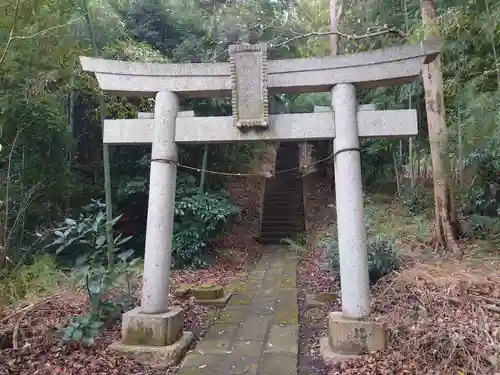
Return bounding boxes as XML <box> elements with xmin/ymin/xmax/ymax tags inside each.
<box><xmin>48</xmin><ymin>201</ymin><xmax>139</xmax><ymax>345</ymax></box>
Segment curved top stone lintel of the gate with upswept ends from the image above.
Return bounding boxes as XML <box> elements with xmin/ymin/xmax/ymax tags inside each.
<box><xmin>80</xmin><ymin>39</ymin><xmax>443</xmax><ymax>96</ymax></box>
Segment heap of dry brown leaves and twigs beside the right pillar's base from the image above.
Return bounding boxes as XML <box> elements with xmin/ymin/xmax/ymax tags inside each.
<box><xmin>330</xmin><ymin>262</ymin><xmax>500</xmax><ymax>375</ymax></box>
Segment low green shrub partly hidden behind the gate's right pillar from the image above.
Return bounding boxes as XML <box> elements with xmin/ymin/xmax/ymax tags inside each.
<box><xmin>323</xmin><ymin>233</ymin><xmax>401</xmax><ymax>285</ymax></box>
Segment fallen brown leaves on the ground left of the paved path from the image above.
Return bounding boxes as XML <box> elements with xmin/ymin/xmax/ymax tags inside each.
<box><xmin>0</xmin><ymin>178</ymin><xmax>260</xmax><ymax>375</ymax></box>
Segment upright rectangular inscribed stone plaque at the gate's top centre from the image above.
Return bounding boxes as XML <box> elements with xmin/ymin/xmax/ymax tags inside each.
<box><xmin>229</xmin><ymin>43</ymin><xmax>269</xmax><ymax>127</ymax></box>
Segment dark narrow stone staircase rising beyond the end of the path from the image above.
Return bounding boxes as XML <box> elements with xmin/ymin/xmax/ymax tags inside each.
<box><xmin>259</xmin><ymin>142</ymin><xmax>305</xmax><ymax>244</ymax></box>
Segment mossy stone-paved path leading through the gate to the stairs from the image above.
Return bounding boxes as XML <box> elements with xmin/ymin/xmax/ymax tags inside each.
<box><xmin>179</xmin><ymin>245</ymin><xmax>299</xmax><ymax>375</ymax></box>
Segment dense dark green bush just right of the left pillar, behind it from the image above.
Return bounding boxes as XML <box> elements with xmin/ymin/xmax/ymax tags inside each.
<box><xmin>172</xmin><ymin>178</ymin><xmax>239</xmax><ymax>267</ymax></box>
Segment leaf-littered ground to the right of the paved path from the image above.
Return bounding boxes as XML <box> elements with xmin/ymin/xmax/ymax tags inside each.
<box><xmin>299</xmin><ymin>181</ymin><xmax>500</xmax><ymax>375</ymax></box>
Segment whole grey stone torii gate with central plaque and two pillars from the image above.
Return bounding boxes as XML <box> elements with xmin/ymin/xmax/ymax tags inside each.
<box><xmin>81</xmin><ymin>40</ymin><xmax>441</xmax><ymax>363</ymax></box>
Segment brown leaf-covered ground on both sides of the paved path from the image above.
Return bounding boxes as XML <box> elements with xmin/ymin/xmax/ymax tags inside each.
<box><xmin>0</xmin><ymin>178</ymin><xmax>500</xmax><ymax>375</ymax></box>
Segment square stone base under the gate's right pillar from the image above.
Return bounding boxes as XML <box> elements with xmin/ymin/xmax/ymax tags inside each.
<box><xmin>320</xmin><ymin>311</ymin><xmax>387</xmax><ymax>362</ymax></box>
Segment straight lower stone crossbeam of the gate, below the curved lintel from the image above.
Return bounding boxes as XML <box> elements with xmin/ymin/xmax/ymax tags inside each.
<box><xmin>103</xmin><ymin>110</ymin><xmax>417</xmax><ymax>144</ymax></box>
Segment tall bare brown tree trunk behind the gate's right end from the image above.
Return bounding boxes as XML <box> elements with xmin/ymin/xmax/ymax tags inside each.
<box><xmin>420</xmin><ymin>0</ymin><xmax>462</xmax><ymax>257</ymax></box>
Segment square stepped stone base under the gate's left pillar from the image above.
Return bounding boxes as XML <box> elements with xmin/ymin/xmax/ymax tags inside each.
<box><xmin>108</xmin><ymin>306</ymin><xmax>193</xmax><ymax>367</ymax></box>
